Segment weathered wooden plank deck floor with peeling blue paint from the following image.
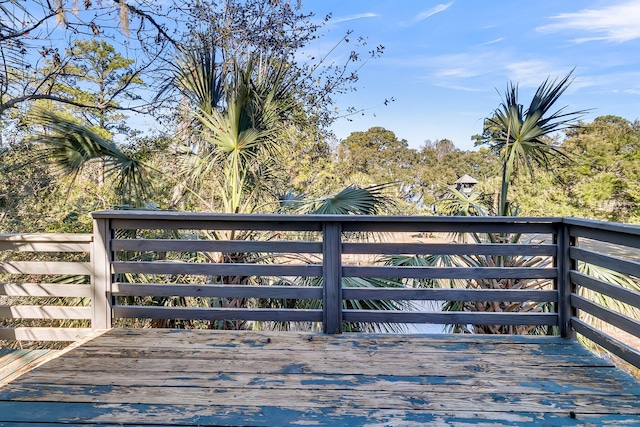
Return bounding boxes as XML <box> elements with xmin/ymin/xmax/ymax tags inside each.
<box><xmin>0</xmin><ymin>329</ymin><xmax>640</xmax><ymax>427</ymax></box>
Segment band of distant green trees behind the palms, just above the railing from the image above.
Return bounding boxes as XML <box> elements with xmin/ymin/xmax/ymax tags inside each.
<box><xmin>0</xmin><ymin>112</ymin><xmax>640</xmax><ymax>232</ymax></box>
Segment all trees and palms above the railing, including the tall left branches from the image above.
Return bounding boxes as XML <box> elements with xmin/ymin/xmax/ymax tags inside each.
<box><xmin>0</xmin><ymin>0</ymin><xmax>640</xmax><ymax>232</ymax></box>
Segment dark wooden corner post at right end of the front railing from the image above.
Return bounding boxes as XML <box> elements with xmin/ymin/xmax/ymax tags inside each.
<box><xmin>556</xmin><ymin>223</ymin><xmax>576</xmax><ymax>339</ymax></box>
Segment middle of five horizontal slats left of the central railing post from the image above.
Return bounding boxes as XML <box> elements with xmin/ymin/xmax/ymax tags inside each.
<box><xmin>111</xmin><ymin>261</ymin><xmax>322</xmax><ymax>277</ymax></box>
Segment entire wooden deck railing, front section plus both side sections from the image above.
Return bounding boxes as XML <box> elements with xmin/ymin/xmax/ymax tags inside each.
<box><xmin>0</xmin><ymin>211</ymin><xmax>640</xmax><ymax>372</ymax></box>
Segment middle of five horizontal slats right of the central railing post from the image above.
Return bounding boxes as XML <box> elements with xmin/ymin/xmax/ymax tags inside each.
<box><xmin>342</xmin><ymin>266</ymin><xmax>558</xmax><ymax>279</ymax></box>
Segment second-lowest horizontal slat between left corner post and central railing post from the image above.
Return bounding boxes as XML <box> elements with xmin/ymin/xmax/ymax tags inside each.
<box><xmin>112</xmin><ymin>283</ymin><xmax>322</xmax><ymax>299</ymax></box>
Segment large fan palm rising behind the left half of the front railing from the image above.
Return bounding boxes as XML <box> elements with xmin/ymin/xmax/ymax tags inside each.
<box><xmin>176</xmin><ymin>49</ymin><xmax>293</xmax><ymax>213</ymax></box>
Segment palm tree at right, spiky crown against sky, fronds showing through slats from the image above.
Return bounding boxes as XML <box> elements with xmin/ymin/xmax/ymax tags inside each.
<box><xmin>383</xmin><ymin>73</ymin><xmax>640</xmax><ymax>333</ymax></box>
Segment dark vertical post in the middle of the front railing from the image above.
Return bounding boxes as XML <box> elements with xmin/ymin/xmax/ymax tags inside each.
<box><xmin>322</xmin><ymin>221</ymin><xmax>342</xmax><ymax>334</ymax></box>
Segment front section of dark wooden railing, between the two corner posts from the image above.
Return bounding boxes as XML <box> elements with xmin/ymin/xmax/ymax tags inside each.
<box><xmin>93</xmin><ymin>212</ymin><xmax>562</xmax><ymax>333</ymax></box>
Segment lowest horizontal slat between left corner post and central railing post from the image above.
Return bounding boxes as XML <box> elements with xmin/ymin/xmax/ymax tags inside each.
<box><xmin>113</xmin><ymin>305</ymin><xmax>322</xmax><ymax>322</ymax></box>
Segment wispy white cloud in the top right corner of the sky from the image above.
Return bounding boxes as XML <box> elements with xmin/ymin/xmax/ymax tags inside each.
<box><xmin>537</xmin><ymin>0</ymin><xmax>640</xmax><ymax>43</ymax></box>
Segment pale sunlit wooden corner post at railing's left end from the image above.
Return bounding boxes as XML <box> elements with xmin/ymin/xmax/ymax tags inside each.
<box><xmin>91</xmin><ymin>218</ymin><xmax>111</xmax><ymax>329</ymax></box>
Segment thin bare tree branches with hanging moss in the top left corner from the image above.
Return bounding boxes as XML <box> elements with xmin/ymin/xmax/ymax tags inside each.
<box><xmin>0</xmin><ymin>0</ymin><xmax>177</xmax><ymax>122</ymax></box>
